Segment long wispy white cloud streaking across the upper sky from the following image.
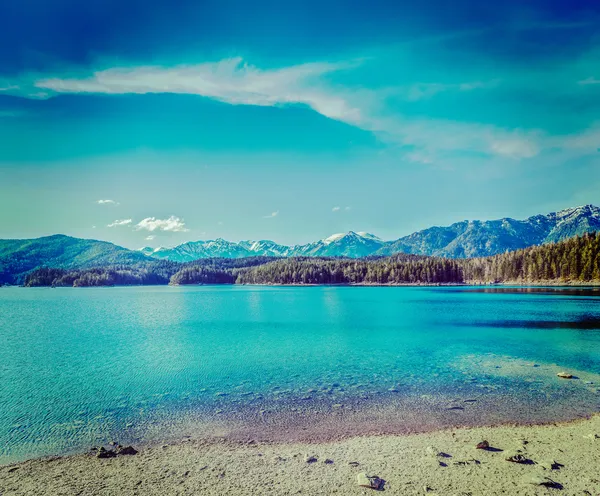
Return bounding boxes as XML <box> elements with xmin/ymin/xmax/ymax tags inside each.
<box><xmin>11</xmin><ymin>57</ymin><xmax>596</xmax><ymax>162</ymax></box>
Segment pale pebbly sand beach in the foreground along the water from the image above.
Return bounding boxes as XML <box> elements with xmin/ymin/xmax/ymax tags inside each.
<box><xmin>0</xmin><ymin>415</ymin><xmax>600</xmax><ymax>496</ymax></box>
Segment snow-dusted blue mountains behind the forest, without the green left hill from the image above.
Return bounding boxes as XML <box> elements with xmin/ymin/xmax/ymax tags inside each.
<box><xmin>141</xmin><ymin>205</ymin><xmax>600</xmax><ymax>262</ymax></box>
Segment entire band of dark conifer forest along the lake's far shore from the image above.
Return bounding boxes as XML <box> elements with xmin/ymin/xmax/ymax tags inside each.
<box><xmin>18</xmin><ymin>233</ymin><xmax>600</xmax><ymax>286</ymax></box>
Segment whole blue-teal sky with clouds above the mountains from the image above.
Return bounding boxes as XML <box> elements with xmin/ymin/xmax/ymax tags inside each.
<box><xmin>0</xmin><ymin>0</ymin><xmax>600</xmax><ymax>248</ymax></box>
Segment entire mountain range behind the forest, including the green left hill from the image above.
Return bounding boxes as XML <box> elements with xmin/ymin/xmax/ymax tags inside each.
<box><xmin>0</xmin><ymin>205</ymin><xmax>600</xmax><ymax>284</ymax></box>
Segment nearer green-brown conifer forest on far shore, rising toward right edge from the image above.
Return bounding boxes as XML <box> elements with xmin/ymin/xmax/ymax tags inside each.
<box><xmin>237</xmin><ymin>233</ymin><xmax>600</xmax><ymax>284</ymax></box>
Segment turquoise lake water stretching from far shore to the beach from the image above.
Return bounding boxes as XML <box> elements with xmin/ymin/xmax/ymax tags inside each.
<box><xmin>0</xmin><ymin>286</ymin><xmax>600</xmax><ymax>463</ymax></box>
